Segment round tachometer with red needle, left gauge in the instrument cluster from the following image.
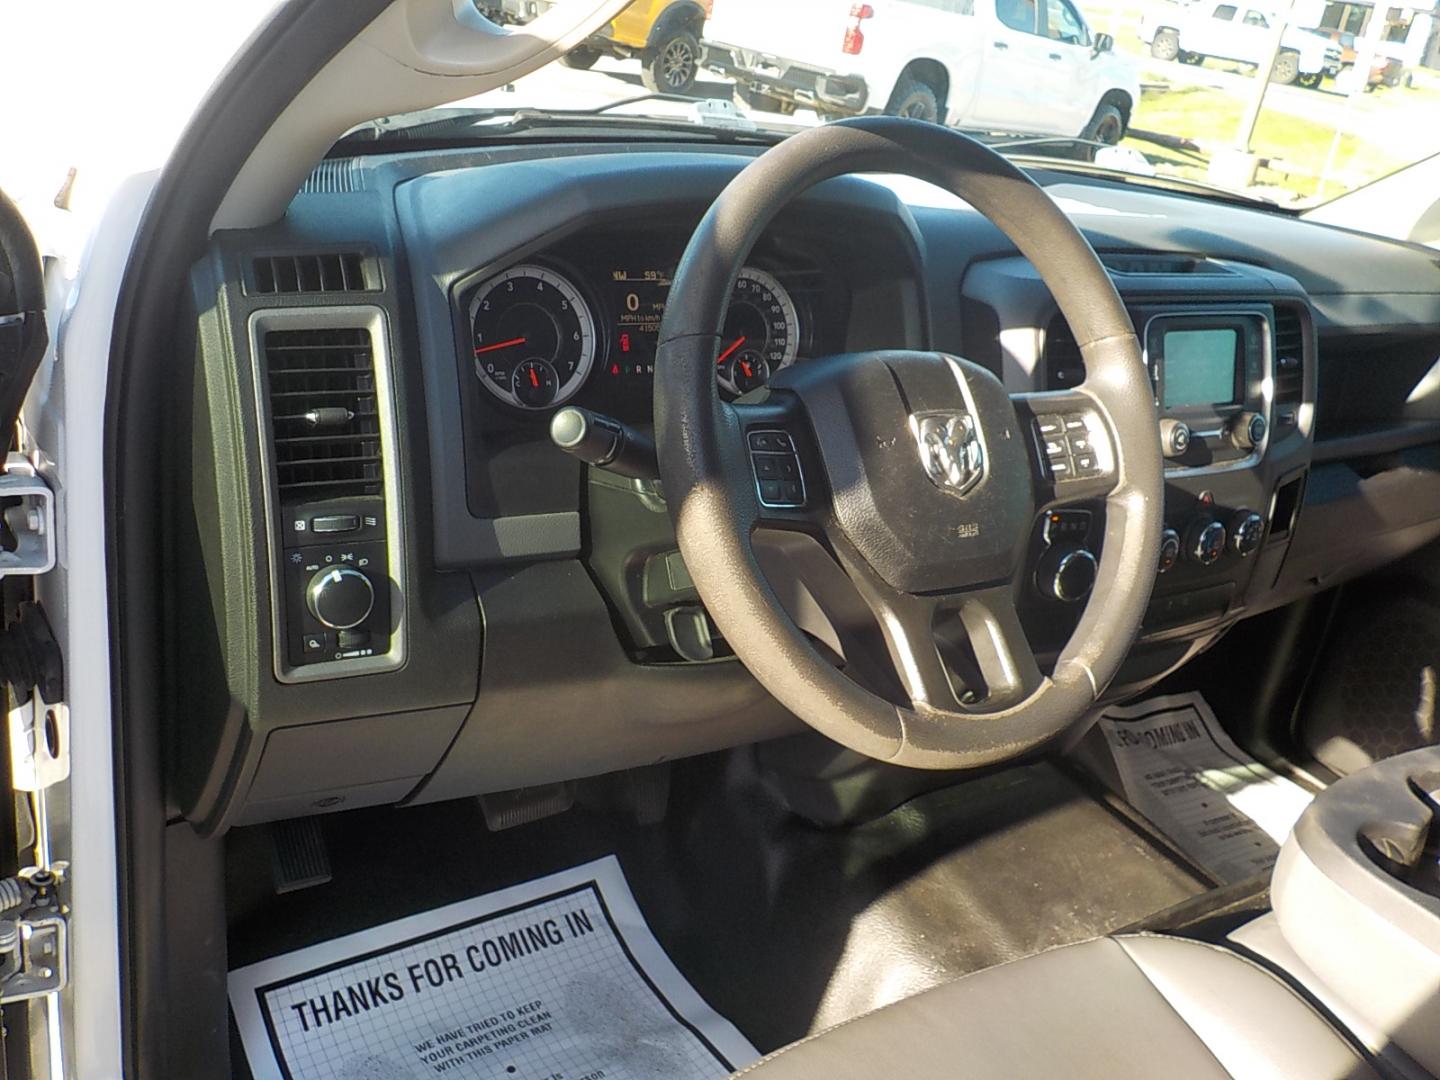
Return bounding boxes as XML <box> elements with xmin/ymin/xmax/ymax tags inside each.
<box><xmin>469</xmin><ymin>264</ymin><xmax>596</xmax><ymax>409</ymax></box>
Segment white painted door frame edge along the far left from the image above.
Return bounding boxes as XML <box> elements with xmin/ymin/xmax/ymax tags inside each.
<box><xmin>26</xmin><ymin>173</ymin><xmax>158</xmax><ymax>1080</ymax></box>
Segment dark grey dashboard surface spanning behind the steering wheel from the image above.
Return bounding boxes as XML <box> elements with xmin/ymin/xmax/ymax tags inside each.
<box><xmin>179</xmin><ymin>144</ymin><xmax>1440</xmax><ymax>828</ymax></box>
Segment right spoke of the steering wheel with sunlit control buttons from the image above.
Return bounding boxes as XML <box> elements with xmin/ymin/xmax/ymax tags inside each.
<box><xmin>1011</xmin><ymin>386</ymin><xmax>1119</xmax><ymax>510</ymax></box>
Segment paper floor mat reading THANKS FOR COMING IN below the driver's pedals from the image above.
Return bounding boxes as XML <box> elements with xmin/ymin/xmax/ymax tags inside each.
<box><xmin>229</xmin><ymin>857</ymin><xmax>759</xmax><ymax>1080</ymax></box>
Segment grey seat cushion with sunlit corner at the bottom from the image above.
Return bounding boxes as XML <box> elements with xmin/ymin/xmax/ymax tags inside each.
<box><xmin>739</xmin><ymin>935</ymin><xmax>1375</xmax><ymax>1080</ymax></box>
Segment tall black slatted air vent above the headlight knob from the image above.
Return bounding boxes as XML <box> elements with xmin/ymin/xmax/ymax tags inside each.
<box><xmin>264</xmin><ymin>328</ymin><xmax>383</xmax><ymax>504</ymax></box>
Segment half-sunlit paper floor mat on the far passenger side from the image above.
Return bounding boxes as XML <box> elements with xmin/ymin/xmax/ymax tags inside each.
<box><xmin>1097</xmin><ymin>693</ymin><xmax>1313</xmax><ymax>883</ymax></box>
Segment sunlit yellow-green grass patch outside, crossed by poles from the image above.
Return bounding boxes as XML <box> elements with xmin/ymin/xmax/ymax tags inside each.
<box><xmin>1129</xmin><ymin>86</ymin><xmax>1404</xmax><ymax>197</ymax></box>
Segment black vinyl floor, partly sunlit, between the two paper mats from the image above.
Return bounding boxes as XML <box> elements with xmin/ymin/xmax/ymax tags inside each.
<box><xmin>228</xmin><ymin>753</ymin><xmax>1205</xmax><ymax>1071</ymax></box>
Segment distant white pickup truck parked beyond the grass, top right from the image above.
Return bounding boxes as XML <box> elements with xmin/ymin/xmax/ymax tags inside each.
<box><xmin>1140</xmin><ymin>0</ymin><xmax>1344</xmax><ymax>88</ymax></box>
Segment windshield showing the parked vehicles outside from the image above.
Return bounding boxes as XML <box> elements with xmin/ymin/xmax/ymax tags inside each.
<box><xmin>365</xmin><ymin>0</ymin><xmax>1440</xmax><ymax>216</ymax></box>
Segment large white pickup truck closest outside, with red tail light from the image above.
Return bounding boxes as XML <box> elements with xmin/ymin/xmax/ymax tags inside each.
<box><xmin>706</xmin><ymin>0</ymin><xmax>1140</xmax><ymax>143</ymax></box>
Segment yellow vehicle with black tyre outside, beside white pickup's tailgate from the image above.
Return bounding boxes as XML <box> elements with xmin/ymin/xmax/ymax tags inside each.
<box><xmin>560</xmin><ymin>0</ymin><xmax>714</xmax><ymax>94</ymax></box>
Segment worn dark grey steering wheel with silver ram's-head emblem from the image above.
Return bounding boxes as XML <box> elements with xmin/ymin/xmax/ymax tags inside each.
<box><xmin>655</xmin><ymin>117</ymin><xmax>1164</xmax><ymax>769</ymax></box>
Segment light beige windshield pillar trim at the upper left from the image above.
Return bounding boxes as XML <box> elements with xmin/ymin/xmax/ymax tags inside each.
<box><xmin>210</xmin><ymin>0</ymin><xmax>629</xmax><ymax>232</ymax></box>
